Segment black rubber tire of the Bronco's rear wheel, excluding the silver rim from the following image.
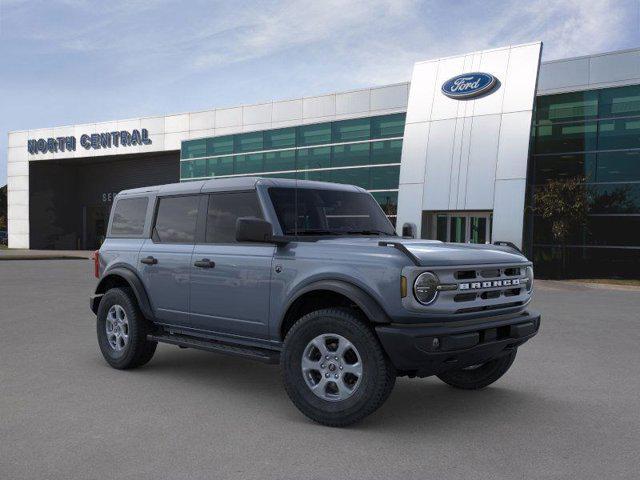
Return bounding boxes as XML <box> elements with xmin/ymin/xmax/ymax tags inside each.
<box><xmin>96</xmin><ymin>288</ymin><xmax>158</xmax><ymax>370</ymax></box>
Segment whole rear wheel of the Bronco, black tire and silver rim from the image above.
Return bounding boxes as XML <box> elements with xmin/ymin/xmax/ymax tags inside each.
<box><xmin>96</xmin><ymin>288</ymin><xmax>158</xmax><ymax>369</ymax></box>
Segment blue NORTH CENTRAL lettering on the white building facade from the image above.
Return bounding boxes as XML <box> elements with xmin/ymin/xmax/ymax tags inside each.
<box><xmin>27</xmin><ymin>128</ymin><xmax>151</xmax><ymax>155</ymax></box>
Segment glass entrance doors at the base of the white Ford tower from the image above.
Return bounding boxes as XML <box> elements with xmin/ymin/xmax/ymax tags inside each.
<box><xmin>423</xmin><ymin>212</ymin><xmax>493</xmax><ymax>243</ymax></box>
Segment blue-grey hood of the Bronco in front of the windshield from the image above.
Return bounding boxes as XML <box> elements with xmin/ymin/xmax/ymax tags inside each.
<box><xmin>312</xmin><ymin>237</ymin><xmax>527</xmax><ymax>266</ymax></box>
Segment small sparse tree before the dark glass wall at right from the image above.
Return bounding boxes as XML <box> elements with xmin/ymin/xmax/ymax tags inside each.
<box><xmin>534</xmin><ymin>177</ymin><xmax>589</xmax><ymax>277</ymax></box>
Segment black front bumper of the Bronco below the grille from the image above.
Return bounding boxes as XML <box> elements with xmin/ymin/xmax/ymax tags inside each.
<box><xmin>376</xmin><ymin>311</ymin><xmax>540</xmax><ymax>377</ymax></box>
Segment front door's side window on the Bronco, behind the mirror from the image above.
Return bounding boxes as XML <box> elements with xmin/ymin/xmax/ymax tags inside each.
<box><xmin>205</xmin><ymin>192</ymin><xmax>262</xmax><ymax>243</ymax></box>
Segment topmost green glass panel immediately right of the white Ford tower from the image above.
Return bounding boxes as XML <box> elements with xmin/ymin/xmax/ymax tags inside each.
<box><xmin>536</xmin><ymin>90</ymin><xmax>598</xmax><ymax>123</ymax></box>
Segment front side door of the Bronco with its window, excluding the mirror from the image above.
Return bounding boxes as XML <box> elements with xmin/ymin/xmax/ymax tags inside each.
<box><xmin>190</xmin><ymin>191</ymin><xmax>275</xmax><ymax>338</ymax></box>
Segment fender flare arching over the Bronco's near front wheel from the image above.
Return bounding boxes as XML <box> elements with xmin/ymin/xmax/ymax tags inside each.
<box><xmin>278</xmin><ymin>280</ymin><xmax>391</xmax><ymax>329</ymax></box>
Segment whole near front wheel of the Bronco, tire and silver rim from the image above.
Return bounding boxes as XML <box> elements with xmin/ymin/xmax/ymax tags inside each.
<box><xmin>280</xmin><ymin>308</ymin><xmax>396</xmax><ymax>427</ymax></box>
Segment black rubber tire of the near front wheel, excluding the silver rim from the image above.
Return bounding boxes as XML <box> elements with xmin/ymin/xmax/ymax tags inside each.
<box><xmin>280</xmin><ymin>308</ymin><xmax>396</xmax><ymax>427</ymax></box>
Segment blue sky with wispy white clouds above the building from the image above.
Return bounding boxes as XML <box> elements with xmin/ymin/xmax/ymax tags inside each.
<box><xmin>0</xmin><ymin>0</ymin><xmax>640</xmax><ymax>185</ymax></box>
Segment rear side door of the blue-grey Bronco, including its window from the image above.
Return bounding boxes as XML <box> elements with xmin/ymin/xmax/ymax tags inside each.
<box><xmin>138</xmin><ymin>195</ymin><xmax>205</xmax><ymax>326</ymax></box>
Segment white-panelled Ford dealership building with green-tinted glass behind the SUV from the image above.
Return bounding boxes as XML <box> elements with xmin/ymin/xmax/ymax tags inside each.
<box><xmin>7</xmin><ymin>42</ymin><xmax>640</xmax><ymax>276</ymax></box>
